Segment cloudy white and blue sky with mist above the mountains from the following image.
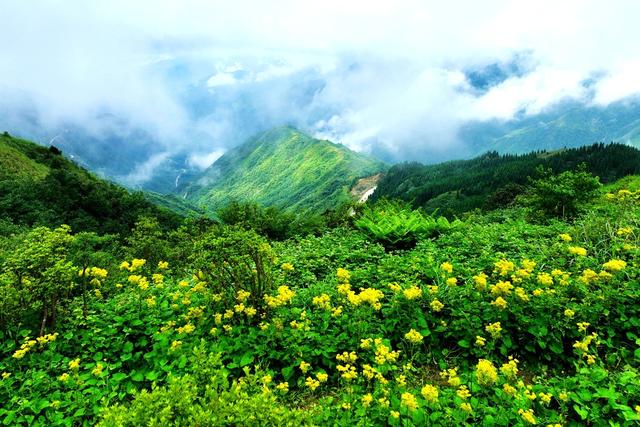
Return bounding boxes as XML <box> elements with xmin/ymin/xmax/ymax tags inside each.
<box><xmin>0</xmin><ymin>0</ymin><xmax>640</xmax><ymax>181</ymax></box>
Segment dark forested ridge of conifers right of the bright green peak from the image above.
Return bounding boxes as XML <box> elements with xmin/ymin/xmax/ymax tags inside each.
<box><xmin>371</xmin><ymin>144</ymin><xmax>640</xmax><ymax>216</ymax></box>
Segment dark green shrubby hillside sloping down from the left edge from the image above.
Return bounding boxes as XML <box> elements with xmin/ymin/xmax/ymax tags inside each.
<box><xmin>0</xmin><ymin>133</ymin><xmax>179</xmax><ymax>234</ymax></box>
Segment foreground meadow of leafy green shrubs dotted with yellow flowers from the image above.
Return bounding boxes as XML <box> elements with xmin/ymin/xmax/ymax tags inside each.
<box><xmin>0</xmin><ymin>146</ymin><xmax>640</xmax><ymax>426</ymax></box>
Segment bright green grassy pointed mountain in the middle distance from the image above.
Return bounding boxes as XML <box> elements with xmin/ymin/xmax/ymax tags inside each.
<box><xmin>189</xmin><ymin>127</ymin><xmax>384</xmax><ymax>211</ymax></box>
